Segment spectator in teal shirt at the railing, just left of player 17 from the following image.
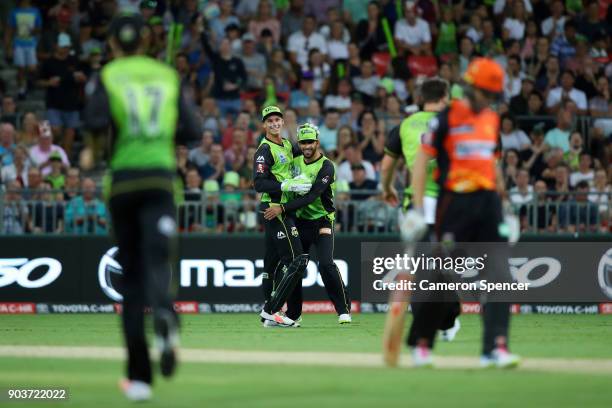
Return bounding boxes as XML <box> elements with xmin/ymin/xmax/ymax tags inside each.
<box><xmin>65</xmin><ymin>178</ymin><xmax>108</xmax><ymax>235</ymax></box>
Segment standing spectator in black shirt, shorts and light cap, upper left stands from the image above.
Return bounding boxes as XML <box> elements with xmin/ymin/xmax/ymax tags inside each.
<box><xmin>39</xmin><ymin>33</ymin><xmax>87</xmax><ymax>155</ymax></box>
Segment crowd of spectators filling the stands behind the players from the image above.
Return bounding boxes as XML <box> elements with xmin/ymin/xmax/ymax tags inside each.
<box><xmin>0</xmin><ymin>0</ymin><xmax>612</xmax><ymax>234</ymax></box>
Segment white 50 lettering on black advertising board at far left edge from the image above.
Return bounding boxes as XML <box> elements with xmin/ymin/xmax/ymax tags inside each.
<box><xmin>0</xmin><ymin>258</ymin><xmax>62</xmax><ymax>289</ymax></box>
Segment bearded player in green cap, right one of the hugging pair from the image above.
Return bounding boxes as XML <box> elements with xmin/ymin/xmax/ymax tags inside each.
<box><xmin>264</xmin><ymin>123</ymin><xmax>351</xmax><ymax>324</ymax></box>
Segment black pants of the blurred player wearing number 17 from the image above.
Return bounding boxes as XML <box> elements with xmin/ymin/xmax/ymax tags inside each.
<box><xmin>110</xmin><ymin>189</ymin><xmax>176</xmax><ymax>383</ymax></box>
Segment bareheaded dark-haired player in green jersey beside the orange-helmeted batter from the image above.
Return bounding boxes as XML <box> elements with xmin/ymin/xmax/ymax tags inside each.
<box><xmin>381</xmin><ymin>78</ymin><xmax>460</xmax><ymax>365</ymax></box>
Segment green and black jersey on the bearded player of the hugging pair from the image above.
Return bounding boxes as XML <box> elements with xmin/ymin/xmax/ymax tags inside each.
<box><xmin>284</xmin><ymin>155</ymin><xmax>336</xmax><ymax>221</ymax></box>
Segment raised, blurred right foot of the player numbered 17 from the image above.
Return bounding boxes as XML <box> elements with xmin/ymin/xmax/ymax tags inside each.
<box><xmin>155</xmin><ymin>310</ymin><xmax>179</xmax><ymax>377</ymax></box>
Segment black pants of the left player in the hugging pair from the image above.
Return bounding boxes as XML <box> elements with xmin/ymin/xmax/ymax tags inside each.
<box><xmin>260</xmin><ymin>203</ymin><xmax>303</xmax><ymax>318</ymax></box>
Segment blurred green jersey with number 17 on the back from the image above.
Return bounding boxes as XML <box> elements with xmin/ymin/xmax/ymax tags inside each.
<box><xmin>101</xmin><ymin>56</ymin><xmax>180</xmax><ymax>171</ymax></box>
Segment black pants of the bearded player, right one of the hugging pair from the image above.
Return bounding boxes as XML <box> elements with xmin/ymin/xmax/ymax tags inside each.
<box><xmin>287</xmin><ymin>218</ymin><xmax>351</xmax><ymax>319</ymax></box>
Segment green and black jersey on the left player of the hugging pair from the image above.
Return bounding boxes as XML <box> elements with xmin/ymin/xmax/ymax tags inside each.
<box><xmin>253</xmin><ymin>138</ymin><xmax>301</xmax><ymax>204</ymax></box>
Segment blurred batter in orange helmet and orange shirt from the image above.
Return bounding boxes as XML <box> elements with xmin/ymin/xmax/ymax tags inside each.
<box><xmin>387</xmin><ymin>58</ymin><xmax>519</xmax><ymax>367</ymax></box>
